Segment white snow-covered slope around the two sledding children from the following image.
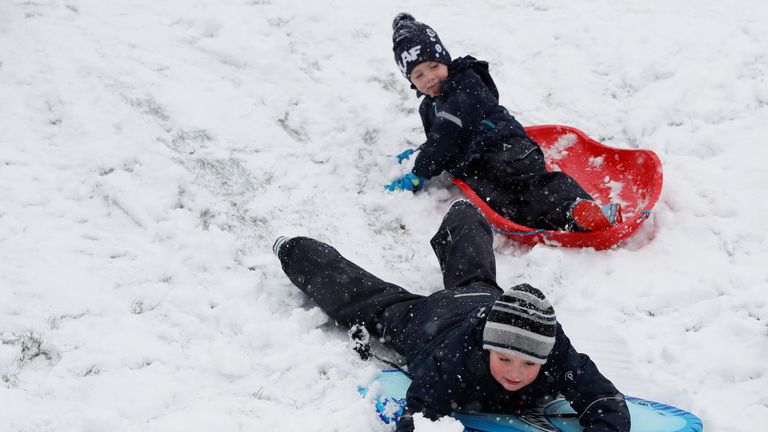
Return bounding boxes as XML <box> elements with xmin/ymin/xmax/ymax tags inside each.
<box><xmin>0</xmin><ymin>0</ymin><xmax>768</xmax><ymax>432</ymax></box>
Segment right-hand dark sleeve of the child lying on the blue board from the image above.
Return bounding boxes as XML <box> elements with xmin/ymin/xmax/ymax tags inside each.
<box><xmin>549</xmin><ymin>325</ymin><xmax>630</xmax><ymax>432</ymax></box>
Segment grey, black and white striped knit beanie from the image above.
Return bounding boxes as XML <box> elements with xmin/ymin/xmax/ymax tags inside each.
<box><xmin>483</xmin><ymin>284</ymin><xmax>557</xmax><ymax>364</ymax></box>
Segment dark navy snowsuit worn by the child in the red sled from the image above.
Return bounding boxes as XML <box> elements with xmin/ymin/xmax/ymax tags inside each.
<box><xmin>412</xmin><ymin>56</ymin><xmax>592</xmax><ymax>230</ymax></box>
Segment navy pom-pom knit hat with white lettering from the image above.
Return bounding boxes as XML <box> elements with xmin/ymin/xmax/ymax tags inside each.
<box><xmin>392</xmin><ymin>12</ymin><xmax>451</xmax><ymax>79</ymax></box>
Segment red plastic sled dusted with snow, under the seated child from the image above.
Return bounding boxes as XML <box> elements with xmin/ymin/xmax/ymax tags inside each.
<box><xmin>453</xmin><ymin>125</ymin><xmax>663</xmax><ymax>249</ymax></box>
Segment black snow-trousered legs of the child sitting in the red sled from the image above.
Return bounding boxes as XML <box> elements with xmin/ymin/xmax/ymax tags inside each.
<box><xmin>467</xmin><ymin>143</ymin><xmax>592</xmax><ymax>230</ymax></box>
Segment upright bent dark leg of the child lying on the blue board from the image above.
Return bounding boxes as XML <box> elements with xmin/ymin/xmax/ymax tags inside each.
<box><xmin>431</xmin><ymin>200</ymin><xmax>497</xmax><ymax>289</ymax></box>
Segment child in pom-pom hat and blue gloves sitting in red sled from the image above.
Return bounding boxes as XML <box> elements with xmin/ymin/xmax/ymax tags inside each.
<box><xmin>386</xmin><ymin>13</ymin><xmax>620</xmax><ymax>231</ymax></box>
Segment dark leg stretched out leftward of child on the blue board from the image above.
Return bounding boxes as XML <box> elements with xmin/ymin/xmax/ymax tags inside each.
<box><xmin>276</xmin><ymin>237</ymin><xmax>424</xmax><ymax>351</ymax></box>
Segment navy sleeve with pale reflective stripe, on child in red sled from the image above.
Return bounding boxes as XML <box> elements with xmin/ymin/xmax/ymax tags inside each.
<box><xmin>412</xmin><ymin>70</ymin><xmax>498</xmax><ymax>179</ymax></box>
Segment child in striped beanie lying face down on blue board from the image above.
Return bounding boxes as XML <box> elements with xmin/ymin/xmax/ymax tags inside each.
<box><xmin>273</xmin><ymin>200</ymin><xmax>630</xmax><ymax>432</ymax></box>
